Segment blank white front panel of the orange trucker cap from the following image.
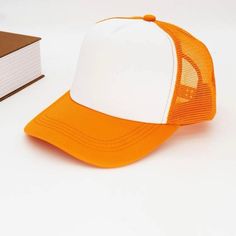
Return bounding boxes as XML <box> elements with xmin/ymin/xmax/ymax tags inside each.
<box><xmin>70</xmin><ymin>19</ymin><xmax>176</xmax><ymax>124</ymax></box>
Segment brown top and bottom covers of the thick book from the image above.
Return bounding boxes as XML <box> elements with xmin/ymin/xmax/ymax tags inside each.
<box><xmin>0</xmin><ymin>31</ymin><xmax>44</xmax><ymax>101</ymax></box>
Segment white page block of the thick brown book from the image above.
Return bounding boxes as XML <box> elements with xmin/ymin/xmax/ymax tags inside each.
<box><xmin>0</xmin><ymin>42</ymin><xmax>42</xmax><ymax>98</ymax></box>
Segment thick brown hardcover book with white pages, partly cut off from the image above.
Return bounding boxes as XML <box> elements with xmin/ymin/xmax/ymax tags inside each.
<box><xmin>0</xmin><ymin>31</ymin><xmax>44</xmax><ymax>101</ymax></box>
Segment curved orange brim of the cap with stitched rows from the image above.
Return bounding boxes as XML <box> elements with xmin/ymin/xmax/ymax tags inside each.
<box><xmin>25</xmin><ymin>92</ymin><xmax>178</xmax><ymax>167</ymax></box>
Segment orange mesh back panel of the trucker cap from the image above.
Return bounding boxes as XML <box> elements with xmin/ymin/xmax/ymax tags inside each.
<box><xmin>156</xmin><ymin>21</ymin><xmax>216</xmax><ymax>125</ymax></box>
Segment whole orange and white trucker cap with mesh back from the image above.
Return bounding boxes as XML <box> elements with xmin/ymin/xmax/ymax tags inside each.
<box><xmin>25</xmin><ymin>15</ymin><xmax>216</xmax><ymax>167</ymax></box>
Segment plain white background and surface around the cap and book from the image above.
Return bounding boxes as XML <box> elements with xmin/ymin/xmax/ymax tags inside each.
<box><xmin>0</xmin><ymin>0</ymin><xmax>236</xmax><ymax>236</ymax></box>
